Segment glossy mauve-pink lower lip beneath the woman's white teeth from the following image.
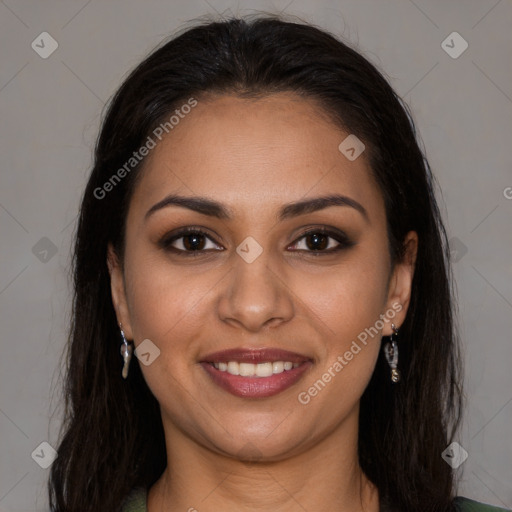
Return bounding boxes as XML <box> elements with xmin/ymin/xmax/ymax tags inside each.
<box><xmin>201</xmin><ymin>361</ymin><xmax>313</xmax><ymax>398</ymax></box>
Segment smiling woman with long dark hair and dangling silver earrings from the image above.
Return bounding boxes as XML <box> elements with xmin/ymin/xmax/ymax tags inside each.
<box><xmin>49</xmin><ymin>17</ymin><xmax>508</xmax><ymax>512</ymax></box>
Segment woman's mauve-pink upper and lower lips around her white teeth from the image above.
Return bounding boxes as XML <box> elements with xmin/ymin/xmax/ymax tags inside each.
<box><xmin>201</xmin><ymin>349</ymin><xmax>313</xmax><ymax>398</ymax></box>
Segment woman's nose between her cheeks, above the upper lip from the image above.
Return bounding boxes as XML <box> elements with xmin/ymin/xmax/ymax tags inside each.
<box><xmin>218</xmin><ymin>251</ymin><xmax>294</xmax><ymax>332</ymax></box>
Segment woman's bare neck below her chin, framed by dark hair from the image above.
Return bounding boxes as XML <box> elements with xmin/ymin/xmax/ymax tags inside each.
<box><xmin>148</xmin><ymin>411</ymin><xmax>379</xmax><ymax>512</ymax></box>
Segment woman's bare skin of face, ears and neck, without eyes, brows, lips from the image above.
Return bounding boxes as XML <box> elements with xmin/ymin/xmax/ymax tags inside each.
<box><xmin>108</xmin><ymin>93</ymin><xmax>417</xmax><ymax>512</ymax></box>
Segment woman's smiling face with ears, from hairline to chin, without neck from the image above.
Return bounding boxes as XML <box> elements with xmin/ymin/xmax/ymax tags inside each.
<box><xmin>109</xmin><ymin>93</ymin><xmax>416</xmax><ymax>460</ymax></box>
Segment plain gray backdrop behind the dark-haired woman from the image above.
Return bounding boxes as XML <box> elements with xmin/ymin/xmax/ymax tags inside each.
<box><xmin>0</xmin><ymin>0</ymin><xmax>512</xmax><ymax>512</ymax></box>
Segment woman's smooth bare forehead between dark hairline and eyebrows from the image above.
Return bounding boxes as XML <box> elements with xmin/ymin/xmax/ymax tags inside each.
<box><xmin>128</xmin><ymin>93</ymin><xmax>383</xmax><ymax>222</ymax></box>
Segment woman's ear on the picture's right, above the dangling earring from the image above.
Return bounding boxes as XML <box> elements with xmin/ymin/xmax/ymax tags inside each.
<box><xmin>382</xmin><ymin>231</ymin><xmax>418</xmax><ymax>336</ymax></box>
